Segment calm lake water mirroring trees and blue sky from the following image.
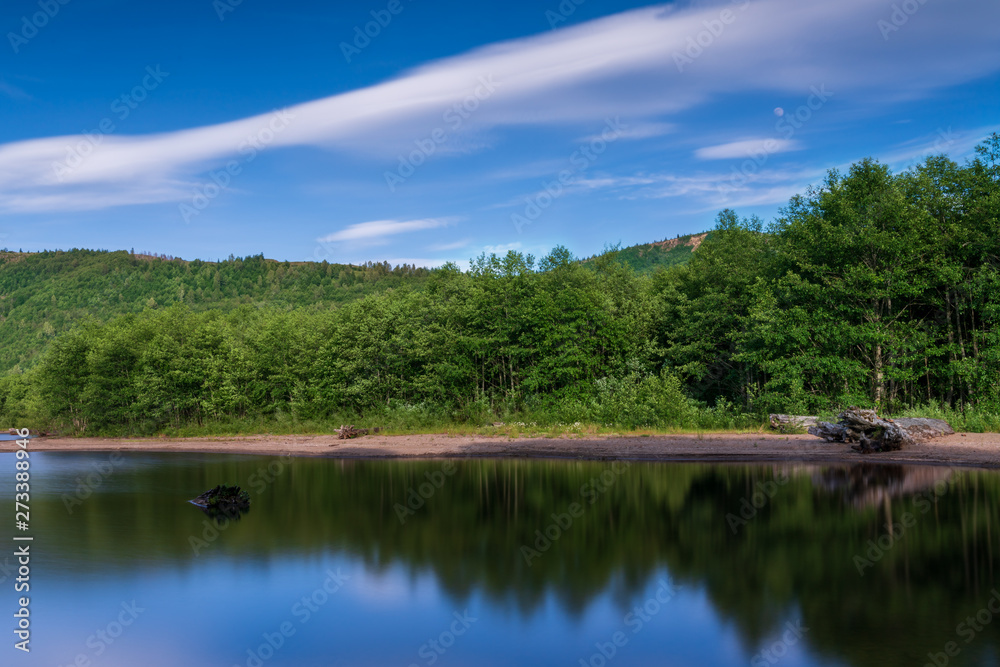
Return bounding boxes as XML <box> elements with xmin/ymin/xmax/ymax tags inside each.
<box><xmin>0</xmin><ymin>453</ymin><xmax>1000</xmax><ymax>667</ymax></box>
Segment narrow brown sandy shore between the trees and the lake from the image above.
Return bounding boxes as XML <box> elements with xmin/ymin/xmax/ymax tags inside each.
<box><xmin>7</xmin><ymin>433</ymin><xmax>1000</xmax><ymax>468</ymax></box>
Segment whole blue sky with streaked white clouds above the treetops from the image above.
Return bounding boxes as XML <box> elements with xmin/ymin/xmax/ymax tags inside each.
<box><xmin>0</xmin><ymin>0</ymin><xmax>1000</xmax><ymax>265</ymax></box>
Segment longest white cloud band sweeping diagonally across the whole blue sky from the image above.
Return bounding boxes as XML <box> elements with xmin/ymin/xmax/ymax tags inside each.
<box><xmin>0</xmin><ymin>0</ymin><xmax>1000</xmax><ymax>212</ymax></box>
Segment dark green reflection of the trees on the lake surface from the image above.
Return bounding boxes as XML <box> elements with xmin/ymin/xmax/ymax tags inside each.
<box><xmin>25</xmin><ymin>455</ymin><xmax>1000</xmax><ymax>667</ymax></box>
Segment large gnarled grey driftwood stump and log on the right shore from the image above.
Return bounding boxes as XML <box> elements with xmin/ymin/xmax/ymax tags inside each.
<box><xmin>808</xmin><ymin>407</ymin><xmax>955</xmax><ymax>454</ymax></box>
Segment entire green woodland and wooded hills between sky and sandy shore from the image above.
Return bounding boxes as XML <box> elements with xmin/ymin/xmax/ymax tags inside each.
<box><xmin>0</xmin><ymin>134</ymin><xmax>1000</xmax><ymax>434</ymax></box>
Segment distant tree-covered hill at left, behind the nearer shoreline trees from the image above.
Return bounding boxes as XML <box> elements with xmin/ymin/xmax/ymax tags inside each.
<box><xmin>0</xmin><ymin>250</ymin><xmax>431</xmax><ymax>372</ymax></box>
